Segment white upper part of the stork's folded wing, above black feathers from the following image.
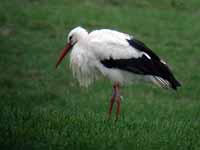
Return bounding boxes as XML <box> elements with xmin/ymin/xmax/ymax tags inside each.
<box><xmin>88</xmin><ymin>29</ymin><xmax>141</xmax><ymax>59</ymax></box>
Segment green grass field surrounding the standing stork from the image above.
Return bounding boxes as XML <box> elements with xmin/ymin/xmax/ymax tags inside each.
<box><xmin>0</xmin><ymin>0</ymin><xmax>200</xmax><ymax>150</ymax></box>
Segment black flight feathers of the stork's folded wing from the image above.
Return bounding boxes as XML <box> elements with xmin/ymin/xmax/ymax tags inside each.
<box><xmin>101</xmin><ymin>39</ymin><xmax>180</xmax><ymax>89</ymax></box>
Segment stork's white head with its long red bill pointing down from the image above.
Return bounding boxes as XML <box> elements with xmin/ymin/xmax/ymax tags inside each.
<box><xmin>56</xmin><ymin>27</ymin><xmax>88</xmax><ymax>68</ymax></box>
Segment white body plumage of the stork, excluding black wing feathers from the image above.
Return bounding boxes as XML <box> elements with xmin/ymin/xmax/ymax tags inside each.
<box><xmin>69</xmin><ymin>27</ymin><xmax>154</xmax><ymax>87</ymax></box>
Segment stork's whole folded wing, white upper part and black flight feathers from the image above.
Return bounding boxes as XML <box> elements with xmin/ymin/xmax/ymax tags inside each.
<box><xmin>88</xmin><ymin>31</ymin><xmax>180</xmax><ymax>89</ymax></box>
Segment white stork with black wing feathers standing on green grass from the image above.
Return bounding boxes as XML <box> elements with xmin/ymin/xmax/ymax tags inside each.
<box><xmin>56</xmin><ymin>26</ymin><xmax>181</xmax><ymax>120</ymax></box>
